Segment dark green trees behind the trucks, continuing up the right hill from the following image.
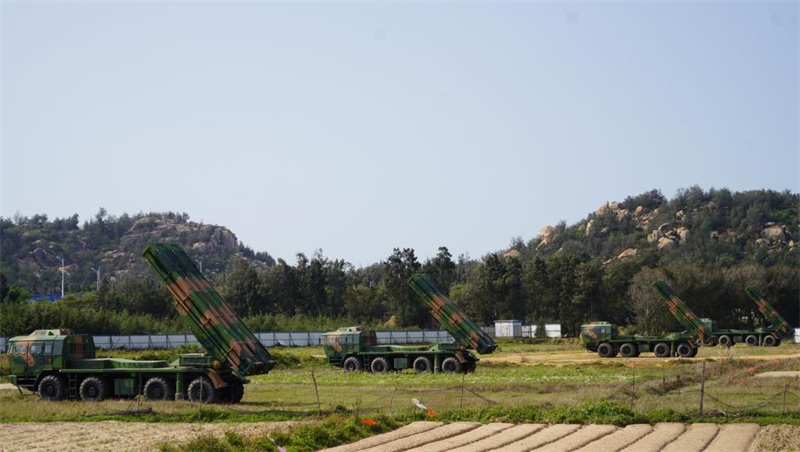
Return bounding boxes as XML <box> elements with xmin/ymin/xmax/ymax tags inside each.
<box><xmin>0</xmin><ymin>187</ymin><xmax>800</xmax><ymax>335</ymax></box>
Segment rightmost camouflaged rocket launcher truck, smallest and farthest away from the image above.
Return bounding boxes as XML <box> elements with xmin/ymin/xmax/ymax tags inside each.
<box><xmin>688</xmin><ymin>287</ymin><xmax>791</xmax><ymax>347</ymax></box>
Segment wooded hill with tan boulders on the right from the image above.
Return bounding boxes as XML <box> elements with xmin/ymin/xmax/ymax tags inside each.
<box><xmin>512</xmin><ymin>187</ymin><xmax>800</xmax><ymax>266</ymax></box>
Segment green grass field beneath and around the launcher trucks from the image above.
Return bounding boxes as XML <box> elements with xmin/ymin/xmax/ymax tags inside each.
<box><xmin>0</xmin><ymin>341</ymin><xmax>800</xmax><ymax>423</ymax></box>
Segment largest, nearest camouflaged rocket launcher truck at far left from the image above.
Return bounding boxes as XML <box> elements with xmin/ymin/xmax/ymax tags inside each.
<box><xmin>7</xmin><ymin>244</ymin><xmax>275</xmax><ymax>403</ymax></box>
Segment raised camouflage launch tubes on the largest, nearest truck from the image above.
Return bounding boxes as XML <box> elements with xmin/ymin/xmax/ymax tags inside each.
<box><xmin>142</xmin><ymin>244</ymin><xmax>275</xmax><ymax>382</ymax></box>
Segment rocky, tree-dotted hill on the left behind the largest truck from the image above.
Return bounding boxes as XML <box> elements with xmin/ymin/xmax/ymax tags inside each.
<box><xmin>0</xmin><ymin>209</ymin><xmax>274</xmax><ymax>293</ymax></box>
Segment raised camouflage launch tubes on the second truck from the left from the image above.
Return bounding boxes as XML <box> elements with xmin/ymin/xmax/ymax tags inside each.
<box><xmin>408</xmin><ymin>273</ymin><xmax>497</xmax><ymax>355</ymax></box>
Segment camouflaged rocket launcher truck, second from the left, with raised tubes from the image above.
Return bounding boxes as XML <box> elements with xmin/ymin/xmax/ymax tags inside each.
<box><xmin>323</xmin><ymin>273</ymin><xmax>497</xmax><ymax>373</ymax></box>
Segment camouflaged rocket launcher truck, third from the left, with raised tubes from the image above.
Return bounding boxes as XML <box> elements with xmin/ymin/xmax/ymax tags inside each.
<box><xmin>580</xmin><ymin>280</ymin><xmax>708</xmax><ymax>358</ymax></box>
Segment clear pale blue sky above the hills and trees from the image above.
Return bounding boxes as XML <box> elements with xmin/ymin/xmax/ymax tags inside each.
<box><xmin>0</xmin><ymin>0</ymin><xmax>800</xmax><ymax>266</ymax></box>
